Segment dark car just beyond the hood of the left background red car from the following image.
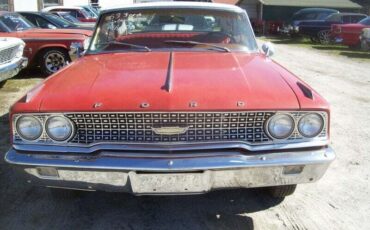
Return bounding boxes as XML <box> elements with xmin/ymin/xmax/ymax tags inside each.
<box><xmin>17</xmin><ymin>12</ymin><xmax>94</xmax><ymax>30</ymax></box>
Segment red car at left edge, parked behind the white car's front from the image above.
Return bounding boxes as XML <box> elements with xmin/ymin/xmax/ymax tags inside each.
<box><xmin>0</xmin><ymin>12</ymin><xmax>92</xmax><ymax>75</ymax></box>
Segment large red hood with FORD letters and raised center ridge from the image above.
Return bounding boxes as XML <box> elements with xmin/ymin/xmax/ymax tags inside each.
<box><xmin>24</xmin><ymin>52</ymin><xmax>312</xmax><ymax>112</ymax></box>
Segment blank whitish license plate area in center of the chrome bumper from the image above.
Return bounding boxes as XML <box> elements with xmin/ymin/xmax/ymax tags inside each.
<box><xmin>129</xmin><ymin>172</ymin><xmax>210</xmax><ymax>194</ymax></box>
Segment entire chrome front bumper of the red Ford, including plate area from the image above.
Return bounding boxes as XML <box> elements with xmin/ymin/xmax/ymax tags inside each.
<box><xmin>5</xmin><ymin>147</ymin><xmax>335</xmax><ymax>195</ymax></box>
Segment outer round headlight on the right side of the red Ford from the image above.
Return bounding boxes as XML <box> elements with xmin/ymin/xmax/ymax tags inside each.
<box><xmin>298</xmin><ymin>113</ymin><xmax>324</xmax><ymax>138</ymax></box>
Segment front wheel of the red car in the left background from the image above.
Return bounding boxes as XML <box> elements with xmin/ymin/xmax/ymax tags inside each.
<box><xmin>39</xmin><ymin>48</ymin><xmax>69</xmax><ymax>76</ymax></box>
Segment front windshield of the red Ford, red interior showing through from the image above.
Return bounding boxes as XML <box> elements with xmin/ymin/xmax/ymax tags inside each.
<box><xmin>89</xmin><ymin>9</ymin><xmax>257</xmax><ymax>53</ymax></box>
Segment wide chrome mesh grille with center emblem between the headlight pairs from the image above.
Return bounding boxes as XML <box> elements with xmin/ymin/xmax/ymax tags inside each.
<box><xmin>66</xmin><ymin>112</ymin><xmax>274</xmax><ymax>144</ymax></box>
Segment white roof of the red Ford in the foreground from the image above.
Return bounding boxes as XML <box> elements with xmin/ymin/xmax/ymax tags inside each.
<box><xmin>101</xmin><ymin>2</ymin><xmax>245</xmax><ymax>14</ymax></box>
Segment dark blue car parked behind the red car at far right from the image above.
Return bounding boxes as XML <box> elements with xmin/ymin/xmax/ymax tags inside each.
<box><xmin>298</xmin><ymin>13</ymin><xmax>367</xmax><ymax>44</ymax></box>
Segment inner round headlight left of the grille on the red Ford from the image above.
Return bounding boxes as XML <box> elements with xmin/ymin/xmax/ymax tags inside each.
<box><xmin>45</xmin><ymin>116</ymin><xmax>73</xmax><ymax>141</ymax></box>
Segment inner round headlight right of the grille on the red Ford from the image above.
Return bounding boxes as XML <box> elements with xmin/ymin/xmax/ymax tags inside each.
<box><xmin>267</xmin><ymin>114</ymin><xmax>294</xmax><ymax>139</ymax></box>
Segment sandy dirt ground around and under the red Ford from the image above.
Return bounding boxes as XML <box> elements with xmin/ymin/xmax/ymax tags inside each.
<box><xmin>0</xmin><ymin>41</ymin><xmax>370</xmax><ymax>230</ymax></box>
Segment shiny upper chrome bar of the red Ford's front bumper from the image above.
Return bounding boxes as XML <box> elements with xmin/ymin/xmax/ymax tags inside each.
<box><xmin>5</xmin><ymin>147</ymin><xmax>335</xmax><ymax>172</ymax></box>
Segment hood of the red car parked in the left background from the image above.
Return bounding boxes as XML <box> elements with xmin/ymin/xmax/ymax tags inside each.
<box><xmin>23</xmin><ymin>28</ymin><xmax>92</xmax><ymax>38</ymax></box>
